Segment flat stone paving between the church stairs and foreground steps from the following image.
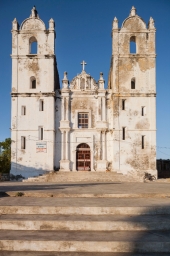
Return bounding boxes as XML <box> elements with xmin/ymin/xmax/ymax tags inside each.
<box><xmin>0</xmin><ymin>182</ymin><xmax>170</xmax><ymax>197</ymax></box>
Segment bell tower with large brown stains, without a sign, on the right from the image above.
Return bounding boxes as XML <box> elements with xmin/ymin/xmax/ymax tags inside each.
<box><xmin>108</xmin><ymin>7</ymin><xmax>157</xmax><ymax>178</ymax></box>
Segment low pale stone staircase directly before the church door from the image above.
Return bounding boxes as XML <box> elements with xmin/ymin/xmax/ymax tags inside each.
<box><xmin>23</xmin><ymin>171</ymin><xmax>140</xmax><ymax>183</ymax></box>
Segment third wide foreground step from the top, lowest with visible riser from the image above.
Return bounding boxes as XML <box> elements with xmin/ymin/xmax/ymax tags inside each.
<box><xmin>0</xmin><ymin>230</ymin><xmax>170</xmax><ymax>253</ymax></box>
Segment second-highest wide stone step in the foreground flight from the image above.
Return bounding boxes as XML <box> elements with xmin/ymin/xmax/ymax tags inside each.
<box><xmin>0</xmin><ymin>214</ymin><xmax>170</xmax><ymax>231</ymax></box>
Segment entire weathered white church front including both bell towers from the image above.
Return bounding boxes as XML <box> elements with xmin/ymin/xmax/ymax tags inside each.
<box><xmin>11</xmin><ymin>7</ymin><xmax>157</xmax><ymax>178</ymax></box>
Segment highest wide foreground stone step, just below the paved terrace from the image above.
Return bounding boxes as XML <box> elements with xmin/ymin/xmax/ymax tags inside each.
<box><xmin>0</xmin><ymin>197</ymin><xmax>170</xmax><ymax>215</ymax></box>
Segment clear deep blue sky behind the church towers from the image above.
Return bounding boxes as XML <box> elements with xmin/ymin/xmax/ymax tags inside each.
<box><xmin>0</xmin><ymin>0</ymin><xmax>170</xmax><ymax>159</ymax></box>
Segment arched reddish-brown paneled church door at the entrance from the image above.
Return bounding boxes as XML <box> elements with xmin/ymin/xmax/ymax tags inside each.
<box><xmin>76</xmin><ymin>143</ymin><xmax>91</xmax><ymax>171</ymax></box>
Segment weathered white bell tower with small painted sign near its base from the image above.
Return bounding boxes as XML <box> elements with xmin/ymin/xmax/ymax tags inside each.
<box><xmin>11</xmin><ymin>6</ymin><xmax>59</xmax><ymax>177</ymax></box>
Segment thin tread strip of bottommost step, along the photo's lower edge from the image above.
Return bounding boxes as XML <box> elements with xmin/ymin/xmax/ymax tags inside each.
<box><xmin>1</xmin><ymin>251</ymin><xmax>169</xmax><ymax>256</ymax></box>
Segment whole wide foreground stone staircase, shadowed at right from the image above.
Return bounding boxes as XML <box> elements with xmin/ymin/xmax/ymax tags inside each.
<box><xmin>0</xmin><ymin>190</ymin><xmax>170</xmax><ymax>256</ymax></box>
